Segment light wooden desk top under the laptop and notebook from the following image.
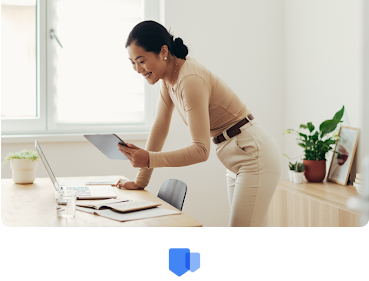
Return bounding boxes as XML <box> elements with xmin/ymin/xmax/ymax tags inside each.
<box><xmin>1</xmin><ymin>176</ymin><xmax>202</xmax><ymax>227</ymax></box>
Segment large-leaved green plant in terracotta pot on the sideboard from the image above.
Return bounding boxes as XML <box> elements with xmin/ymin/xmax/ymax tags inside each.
<box><xmin>283</xmin><ymin>106</ymin><xmax>345</xmax><ymax>182</ymax></box>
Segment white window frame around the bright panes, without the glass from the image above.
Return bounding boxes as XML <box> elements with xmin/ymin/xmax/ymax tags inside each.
<box><xmin>1</xmin><ymin>0</ymin><xmax>162</xmax><ymax>138</ymax></box>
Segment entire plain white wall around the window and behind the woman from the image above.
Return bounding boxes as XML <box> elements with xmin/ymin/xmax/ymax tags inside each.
<box><xmin>1</xmin><ymin>0</ymin><xmax>362</xmax><ymax>226</ymax></box>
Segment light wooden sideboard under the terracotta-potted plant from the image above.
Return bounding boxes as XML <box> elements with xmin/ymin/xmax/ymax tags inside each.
<box><xmin>268</xmin><ymin>179</ymin><xmax>359</xmax><ymax>227</ymax></box>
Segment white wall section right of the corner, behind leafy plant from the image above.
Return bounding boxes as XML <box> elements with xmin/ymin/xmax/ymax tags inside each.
<box><xmin>284</xmin><ymin>0</ymin><xmax>363</xmax><ymax>178</ymax></box>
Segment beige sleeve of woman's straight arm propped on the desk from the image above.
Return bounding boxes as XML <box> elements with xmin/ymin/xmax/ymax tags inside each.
<box><xmin>134</xmin><ymin>81</ymin><xmax>174</xmax><ymax>187</ymax></box>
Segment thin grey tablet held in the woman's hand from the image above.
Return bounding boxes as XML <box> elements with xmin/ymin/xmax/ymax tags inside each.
<box><xmin>83</xmin><ymin>134</ymin><xmax>128</xmax><ymax>160</ymax></box>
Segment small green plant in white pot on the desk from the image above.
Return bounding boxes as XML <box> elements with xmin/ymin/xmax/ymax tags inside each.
<box><xmin>2</xmin><ymin>149</ymin><xmax>40</xmax><ymax>184</ymax></box>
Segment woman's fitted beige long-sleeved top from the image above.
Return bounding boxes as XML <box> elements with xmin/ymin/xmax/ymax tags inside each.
<box><xmin>135</xmin><ymin>57</ymin><xmax>251</xmax><ymax>187</ymax></box>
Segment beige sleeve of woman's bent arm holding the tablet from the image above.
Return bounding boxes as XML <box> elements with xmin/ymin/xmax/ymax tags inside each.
<box><xmin>149</xmin><ymin>75</ymin><xmax>210</xmax><ymax>168</ymax></box>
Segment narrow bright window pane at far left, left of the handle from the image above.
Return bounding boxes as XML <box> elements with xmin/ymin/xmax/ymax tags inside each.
<box><xmin>1</xmin><ymin>0</ymin><xmax>37</xmax><ymax>118</ymax></box>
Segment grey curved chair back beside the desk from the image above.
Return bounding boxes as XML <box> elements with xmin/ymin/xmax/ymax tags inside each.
<box><xmin>158</xmin><ymin>179</ymin><xmax>187</xmax><ymax>211</ymax></box>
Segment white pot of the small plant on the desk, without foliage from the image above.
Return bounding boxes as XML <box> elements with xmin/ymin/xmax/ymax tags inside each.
<box><xmin>10</xmin><ymin>159</ymin><xmax>37</xmax><ymax>184</ymax></box>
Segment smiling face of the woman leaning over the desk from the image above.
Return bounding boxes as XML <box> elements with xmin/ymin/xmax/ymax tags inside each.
<box><xmin>127</xmin><ymin>43</ymin><xmax>167</xmax><ymax>85</ymax></box>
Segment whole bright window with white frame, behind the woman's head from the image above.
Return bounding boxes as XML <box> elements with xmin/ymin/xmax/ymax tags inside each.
<box><xmin>1</xmin><ymin>0</ymin><xmax>159</xmax><ymax>135</ymax></box>
